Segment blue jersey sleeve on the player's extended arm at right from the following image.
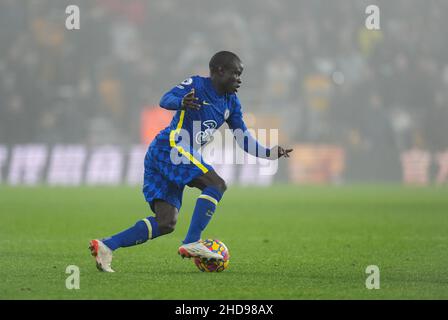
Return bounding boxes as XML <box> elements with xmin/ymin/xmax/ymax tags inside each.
<box><xmin>227</xmin><ymin>95</ymin><xmax>271</xmax><ymax>158</ymax></box>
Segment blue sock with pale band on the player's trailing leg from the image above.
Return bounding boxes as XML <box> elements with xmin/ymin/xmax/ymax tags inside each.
<box><xmin>102</xmin><ymin>217</ymin><xmax>160</xmax><ymax>251</ymax></box>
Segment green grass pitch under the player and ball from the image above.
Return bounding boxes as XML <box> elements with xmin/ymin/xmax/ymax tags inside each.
<box><xmin>0</xmin><ymin>186</ymin><xmax>448</xmax><ymax>299</ymax></box>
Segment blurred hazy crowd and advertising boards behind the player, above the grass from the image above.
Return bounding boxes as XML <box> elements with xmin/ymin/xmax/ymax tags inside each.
<box><xmin>0</xmin><ymin>0</ymin><xmax>448</xmax><ymax>185</ymax></box>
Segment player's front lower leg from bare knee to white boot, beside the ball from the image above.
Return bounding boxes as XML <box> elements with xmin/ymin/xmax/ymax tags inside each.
<box><xmin>179</xmin><ymin>170</ymin><xmax>227</xmax><ymax>260</ymax></box>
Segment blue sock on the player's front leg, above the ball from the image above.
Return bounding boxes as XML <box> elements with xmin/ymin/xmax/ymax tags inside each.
<box><xmin>183</xmin><ymin>187</ymin><xmax>222</xmax><ymax>243</ymax></box>
